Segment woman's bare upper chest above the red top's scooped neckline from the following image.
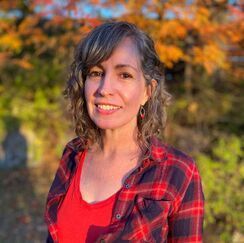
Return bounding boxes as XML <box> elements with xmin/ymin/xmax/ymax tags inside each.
<box><xmin>80</xmin><ymin>152</ymin><xmax>137</xmax><ymax>203</ymax></box>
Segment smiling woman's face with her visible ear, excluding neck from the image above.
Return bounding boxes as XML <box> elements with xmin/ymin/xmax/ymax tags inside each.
<box><xmin>85</xmin><ymin>38</ymin><xmax>148</xmax><ymax>130</ymax></box>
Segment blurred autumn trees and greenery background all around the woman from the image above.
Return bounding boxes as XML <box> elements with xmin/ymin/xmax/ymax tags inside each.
<box><xmin>0</xmin><ymin>0</ymin><xmax>244</xmax><ymax>243</ymax></box>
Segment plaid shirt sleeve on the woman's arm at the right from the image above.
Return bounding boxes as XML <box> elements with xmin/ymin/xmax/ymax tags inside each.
<box><xmin>167</xmin><ymin>166</ymin><xmax>204</xmax><ymax>243</ymax></box>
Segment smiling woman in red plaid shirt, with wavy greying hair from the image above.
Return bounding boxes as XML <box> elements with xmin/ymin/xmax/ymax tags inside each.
<box><xmin>45</xmin><ymin>22</ymin><xmax>203</xmax><ymax>243</ymax></box>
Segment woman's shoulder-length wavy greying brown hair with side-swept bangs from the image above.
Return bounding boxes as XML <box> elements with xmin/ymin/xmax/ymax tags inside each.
<box><xmin>64</xmin><ymin>21</ymin><xmax>170</xmax><ymax>148</ymax></box>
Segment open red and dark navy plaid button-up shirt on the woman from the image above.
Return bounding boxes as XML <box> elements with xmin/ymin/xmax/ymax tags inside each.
<box><xmin>45</xmin><ymin>138</ymin><xmax>204</xmax><ymax>243</ymax></box>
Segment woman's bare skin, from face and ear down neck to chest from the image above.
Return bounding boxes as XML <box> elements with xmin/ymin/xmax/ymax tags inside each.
<box><xmin>80</xmin><ymin>38</ymin><xmax>151</xmax><ymax>203</ymax></box>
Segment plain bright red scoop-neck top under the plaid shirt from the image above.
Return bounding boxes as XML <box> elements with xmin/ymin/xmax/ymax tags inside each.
<box><xmin>57</xmin><ymin>152</ymin><xmax>118</xmax><ymax>243</ymax></box>
